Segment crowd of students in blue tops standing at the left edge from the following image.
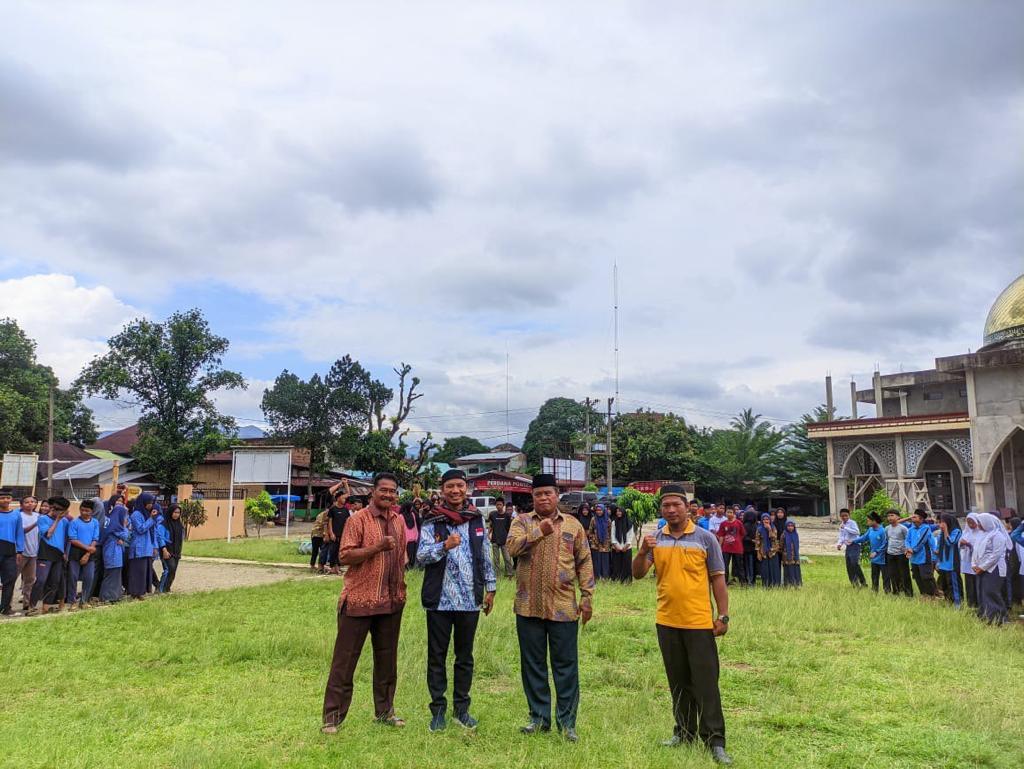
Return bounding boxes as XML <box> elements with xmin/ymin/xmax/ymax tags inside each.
<box><xmin>0</xmin><ymin>484</ymin><xmax>184</xmax><ymax>616</ymax></box>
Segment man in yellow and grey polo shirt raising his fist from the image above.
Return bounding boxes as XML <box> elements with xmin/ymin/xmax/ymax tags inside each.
<box><xmin>633</xmin><ymin>484</ymin><xmax>732</xmax><ymax>765</ymax></box>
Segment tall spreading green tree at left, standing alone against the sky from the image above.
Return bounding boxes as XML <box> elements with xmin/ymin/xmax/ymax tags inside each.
<box><xmin>78</xmin><ymin>309</ymin><xmax>246</xmax><ymax>490</ymax></box>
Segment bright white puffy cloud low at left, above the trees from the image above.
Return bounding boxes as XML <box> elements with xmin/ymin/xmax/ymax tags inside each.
<box><xmin>0</xmin><ymin>274</ymin><xmax>142</xmax><ymax>386</ymax></box>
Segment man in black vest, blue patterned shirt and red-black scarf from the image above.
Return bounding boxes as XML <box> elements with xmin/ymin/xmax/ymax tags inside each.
<box><xmin>416</xmin><ymin>470</ymin><xmax>498</xmax><ymax>731</ymax></box>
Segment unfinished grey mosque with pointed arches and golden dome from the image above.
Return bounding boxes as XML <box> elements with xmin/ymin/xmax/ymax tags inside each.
<box><xmin>808</xmin><ymin>275</ymin><xmax>1024</xmax><ymax>517</ymax></box>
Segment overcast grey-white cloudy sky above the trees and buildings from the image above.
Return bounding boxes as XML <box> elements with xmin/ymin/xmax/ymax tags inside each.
<box><xmin>0</xmin><ymin>0</ymin><xmax>1024</xmax><ymax>442</ymax></box>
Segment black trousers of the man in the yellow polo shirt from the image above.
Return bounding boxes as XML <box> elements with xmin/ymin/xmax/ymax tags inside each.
<box><xmin>657</xmin><ymin>625</ymin><xmax>725</xmax><ymax>747</ymax></box>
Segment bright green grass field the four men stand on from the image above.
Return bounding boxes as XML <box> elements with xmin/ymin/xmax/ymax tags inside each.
<box><xmin>0</xmin><ymin>558</ymin><xmax>1024</xmax><ymax>769</ymax></box>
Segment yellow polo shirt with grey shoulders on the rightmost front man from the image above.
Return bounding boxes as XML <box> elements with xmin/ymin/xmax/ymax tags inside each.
<box><xmin>648</xmin><ymin>520</ymin><xmax>725</xmax><ymax>630</ymax></box>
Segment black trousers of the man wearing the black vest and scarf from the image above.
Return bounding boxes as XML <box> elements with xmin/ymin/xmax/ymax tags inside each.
<box><xmin>427</xmin><ymin>609</ymin><xmax>480</xmax><ymax>715</ymax></box>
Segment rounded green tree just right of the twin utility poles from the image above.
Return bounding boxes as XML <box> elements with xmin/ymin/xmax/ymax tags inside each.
<box><xmin>610</xmin><ymin>411</ymin><xmax>697</xmax><ymax>483</ymax></box>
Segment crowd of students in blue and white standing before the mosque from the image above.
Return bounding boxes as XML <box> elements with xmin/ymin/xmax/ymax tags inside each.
<box><xmin>836</xmin><ymin>509</ymin><xmax>1024</xmax><ymax>625</ymax></box>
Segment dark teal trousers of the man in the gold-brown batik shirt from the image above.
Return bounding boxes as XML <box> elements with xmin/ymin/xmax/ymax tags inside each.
<box><xmin>515</xmin><ymin>614</ymin><xmax>580</xmax><ymax>729</ymax></box>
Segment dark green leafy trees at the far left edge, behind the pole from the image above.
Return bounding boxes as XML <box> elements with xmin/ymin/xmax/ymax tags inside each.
<box><xmin>0</xmin><ymin>318</ymin><xmax>96</xmax><ymax>453</ymax></box>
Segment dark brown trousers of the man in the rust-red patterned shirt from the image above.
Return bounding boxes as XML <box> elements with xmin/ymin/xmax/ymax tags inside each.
<box><xmin>324</xmin><ymin>608</ymin><xmax>401</xmax><ymax>726</ymax></box>
